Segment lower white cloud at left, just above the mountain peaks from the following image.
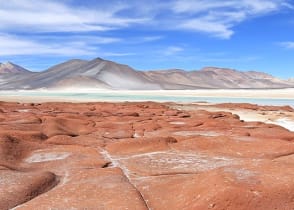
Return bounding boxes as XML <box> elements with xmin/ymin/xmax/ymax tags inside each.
<box><xmin>0</xmin><ymin>34</ymin><xmax>130</xmax><ymax>56</ymax></box>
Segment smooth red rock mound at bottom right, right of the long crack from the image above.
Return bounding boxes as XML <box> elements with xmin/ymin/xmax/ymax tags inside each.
<box><xmin>136</xmin><ymin>162</ymin><xmax>294</xmax><ymax>210</ymax></box>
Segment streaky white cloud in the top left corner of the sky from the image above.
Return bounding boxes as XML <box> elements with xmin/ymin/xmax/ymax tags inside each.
<box><xmin>0</xmin><ymin>0</ymin><xmax>146</xmax><ymax>32</ymax></box>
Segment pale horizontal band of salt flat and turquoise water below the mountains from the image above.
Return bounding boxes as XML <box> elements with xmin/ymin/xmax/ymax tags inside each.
<box><xmin>0</xmin><ymin>88</ymin><xmax>294</xmax><ymax>104</ymax></box>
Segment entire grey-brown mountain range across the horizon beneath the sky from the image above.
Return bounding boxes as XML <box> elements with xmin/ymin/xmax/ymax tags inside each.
<box><xmin>0</xmin><ymin>58</ymin><xmax>294</xmax><ymax>90</ymax></box>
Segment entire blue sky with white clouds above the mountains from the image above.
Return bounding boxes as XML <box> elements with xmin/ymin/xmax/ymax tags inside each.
<box><xmin>0</xmin><ymin>0</ymin><xmax>294</xmax><ymax>78</ymax></box>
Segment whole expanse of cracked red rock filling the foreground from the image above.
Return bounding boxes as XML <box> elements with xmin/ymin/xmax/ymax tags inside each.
<box><xmin>0</xmin><ymin>102</ymin><xmax>294</xmax><ymax>210</ymax></box>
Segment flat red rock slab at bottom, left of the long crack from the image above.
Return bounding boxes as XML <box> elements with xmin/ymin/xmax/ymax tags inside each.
<box><xmin>18</xmin><ymin>169</ymin><xmax>147</xmax><ymax>210</ymax></box>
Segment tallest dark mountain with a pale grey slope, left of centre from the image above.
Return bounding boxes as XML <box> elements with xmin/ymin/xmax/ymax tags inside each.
<box><xmin>4</xmin><ymin>58</ymin><xmax>160</xmax><ymax>89</ymax></box>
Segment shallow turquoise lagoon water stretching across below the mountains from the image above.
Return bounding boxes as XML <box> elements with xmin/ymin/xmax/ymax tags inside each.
<box><xmin>0</xmin><ymin>91</ymin><xmax>294</xmax><ymax>107</ymax></box>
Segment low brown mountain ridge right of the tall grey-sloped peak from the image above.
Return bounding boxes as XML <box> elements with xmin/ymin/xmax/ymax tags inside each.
<box><xmin>146</xmin><ymin>67</ymin><xmax>294</xmax><ymax>89</ymax></box>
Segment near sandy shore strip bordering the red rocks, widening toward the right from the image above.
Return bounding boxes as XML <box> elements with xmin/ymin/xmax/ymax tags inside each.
<box><xmin>0</xmin><ymin>96</ymin><xmax>294</xmax><ymax>132</ymax></box>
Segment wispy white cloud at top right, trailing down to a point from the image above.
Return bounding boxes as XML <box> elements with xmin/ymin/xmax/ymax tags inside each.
<box><xmin>171</xmin><ymin>0</ymin><xmax>292</xmax><ymax>39</ymax></box>
